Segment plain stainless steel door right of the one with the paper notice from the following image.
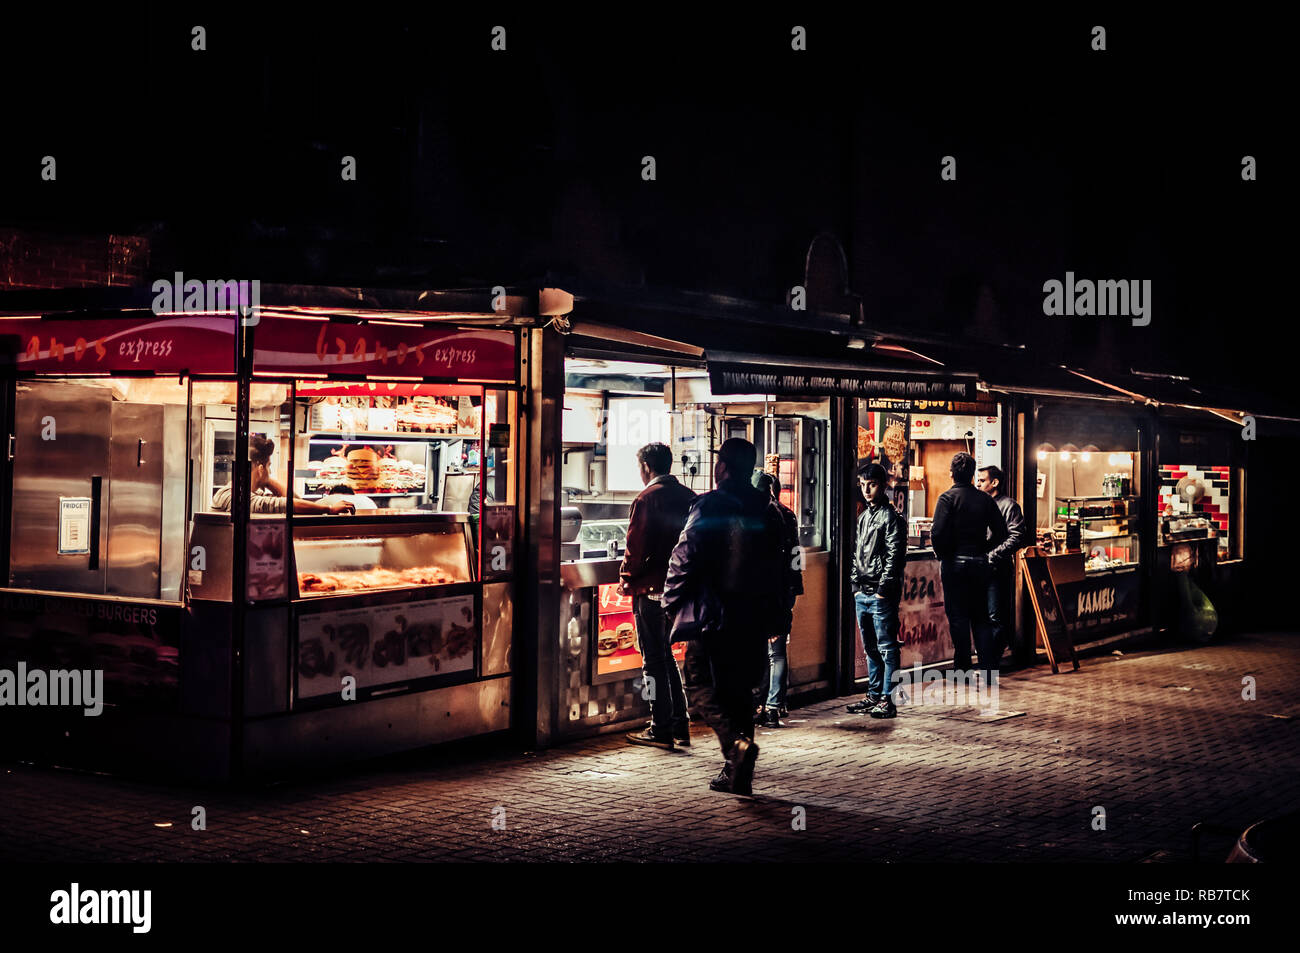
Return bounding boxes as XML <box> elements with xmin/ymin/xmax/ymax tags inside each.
<box><xmin>104</xmin><ymin>402</ymin><xmax>164</xmax><ymax>599</ymax></box>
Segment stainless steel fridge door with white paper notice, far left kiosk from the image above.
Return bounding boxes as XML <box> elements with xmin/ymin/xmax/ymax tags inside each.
<box><xmin>9</xmin><ymin>381</ymin><xmax>113</xmax><ymax>595</ymax></box>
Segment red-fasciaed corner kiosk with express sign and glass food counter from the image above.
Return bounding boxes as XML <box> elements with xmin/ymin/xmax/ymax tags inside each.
<box><xmin>0</xmin><ymin>289</ymin><xmax>521</xmax><ymax>780</ymax></box>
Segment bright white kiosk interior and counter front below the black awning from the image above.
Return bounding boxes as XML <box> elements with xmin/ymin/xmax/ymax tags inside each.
<box><xmin>548</xmin><ymin>348</ymin><xmax>831</xmax><ymax>733</ymax></box>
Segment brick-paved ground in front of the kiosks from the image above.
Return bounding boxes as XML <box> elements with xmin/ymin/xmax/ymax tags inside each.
<box><xmin>0</xmin><ymin>633</ymin><xmax>1300</xmax><ymax>862</ymax></box>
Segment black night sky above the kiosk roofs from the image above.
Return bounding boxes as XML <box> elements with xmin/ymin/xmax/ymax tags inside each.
<box><xmin>0</xmin><ymin>4</ymin><xmax>1295</xmax><ymax>395</ymax></box>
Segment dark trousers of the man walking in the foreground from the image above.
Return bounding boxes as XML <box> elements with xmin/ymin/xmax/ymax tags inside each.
<box><xmin>684</xmin><ymin>629</ymin><xmax>767</xmax><ymax>755</ymax></box>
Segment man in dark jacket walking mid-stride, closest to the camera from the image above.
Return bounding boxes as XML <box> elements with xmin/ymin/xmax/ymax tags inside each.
<box><xmin>663</xmin><ymin>438</ymin><xmax>790</xmax><ymax>794</ymax></box>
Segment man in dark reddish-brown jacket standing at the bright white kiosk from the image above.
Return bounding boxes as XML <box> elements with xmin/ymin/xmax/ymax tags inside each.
<box><xmin>619</xmin><ymin>443</ymin><xmax>696</xmax><ymax>749</ymax></box>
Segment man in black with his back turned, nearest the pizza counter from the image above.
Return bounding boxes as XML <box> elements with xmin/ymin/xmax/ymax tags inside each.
<box><xmin>931</xmin><ymin>452</ymin><xmax>1006</xmax><ymax>684</ymax></box>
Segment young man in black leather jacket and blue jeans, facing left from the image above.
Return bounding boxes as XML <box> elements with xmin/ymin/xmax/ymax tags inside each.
<box><xmin>848</xmin><ymin>463</ymin><xmax>907</xmax><ymax>718</ymax></box>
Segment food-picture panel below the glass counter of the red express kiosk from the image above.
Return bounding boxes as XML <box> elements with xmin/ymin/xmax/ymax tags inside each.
<box><xmin>298</xmin><ymin>594</ymin><xmax>478</xmax><ymax>698</ymax></box>
